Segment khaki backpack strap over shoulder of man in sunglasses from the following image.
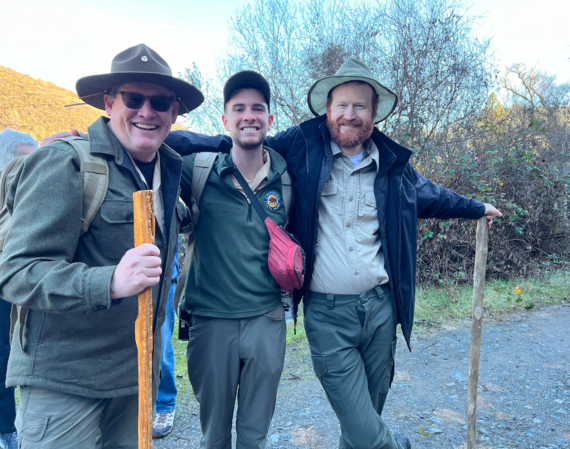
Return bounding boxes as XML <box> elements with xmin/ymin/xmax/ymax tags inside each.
<box><xmin>56</xmin><ymin>136</ymin><xmax>109</xmax><ymax>235</ymax></box>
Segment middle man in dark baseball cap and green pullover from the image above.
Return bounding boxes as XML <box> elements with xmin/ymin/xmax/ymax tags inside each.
<box><xmin>175</xmin><ymin>71</ymin><xmax>290</xmax><ymax>449</ymax></box>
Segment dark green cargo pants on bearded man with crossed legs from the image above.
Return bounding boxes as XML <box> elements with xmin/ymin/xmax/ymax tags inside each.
<box><xmin>304</xmin><ymin>285</ymin><xmax>403</xmax><ymax>449</ymax></box>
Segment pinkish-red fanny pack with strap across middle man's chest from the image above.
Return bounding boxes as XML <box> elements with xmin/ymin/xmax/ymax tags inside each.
<box><xmin>227</xmin><ymin>157</ymin><xmax>305</xmax><ymax>292</ymax></box>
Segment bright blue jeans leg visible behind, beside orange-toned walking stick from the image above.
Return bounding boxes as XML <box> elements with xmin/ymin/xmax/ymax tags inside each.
<box><xmin>155</xmin><ymin>283</ymin><xmax>178</xmax><ymax>413</ymax></box>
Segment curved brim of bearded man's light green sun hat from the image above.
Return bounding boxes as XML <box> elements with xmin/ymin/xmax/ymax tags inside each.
<box><xmin>307</xmin><ymin>75</ymin><xmax>398</xmax><ymax>123</ymax></box>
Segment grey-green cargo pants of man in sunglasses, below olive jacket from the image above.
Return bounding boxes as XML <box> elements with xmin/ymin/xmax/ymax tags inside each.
<box><xmin>16</xmin><ymin>387</ymin><xmax>139</xmax><ymax>449</ymax></box>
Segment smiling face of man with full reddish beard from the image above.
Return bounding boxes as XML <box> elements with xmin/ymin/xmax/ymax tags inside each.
<box><xmin>327</xmin><ymin>82</ymin><xmax>377</xmax><ymax>150</ymax></box>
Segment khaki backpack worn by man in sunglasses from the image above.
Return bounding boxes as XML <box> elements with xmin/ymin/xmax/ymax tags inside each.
<box><xmin>6</xmin><ymin>136</ymin><xmax>109</xmax><ymax>352</ymax></box>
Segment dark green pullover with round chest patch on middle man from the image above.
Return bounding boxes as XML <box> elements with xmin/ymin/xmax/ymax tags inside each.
<box><xmin>180</xmin><ymin>148</ymin><xmax>287</xmax><ymax>318</ymax></box>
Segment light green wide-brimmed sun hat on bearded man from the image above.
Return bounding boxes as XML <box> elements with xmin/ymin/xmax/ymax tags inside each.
<box><xmin>307</xmin><ymin>58</ymin><xmax>398</xmax><ymax>123</ymax></box>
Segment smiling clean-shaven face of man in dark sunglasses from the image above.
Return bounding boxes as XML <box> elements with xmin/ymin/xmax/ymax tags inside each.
<box><xmin>105</xmin><ymin>83</ymin><xmax>179</xmax><ymax>162</ymax></box>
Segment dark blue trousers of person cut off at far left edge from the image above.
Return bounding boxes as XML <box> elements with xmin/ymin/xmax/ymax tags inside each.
<box><xmin>0</xmin><ymin>299</ymin><xmax>16</xmax><ymax>434</ymax></box>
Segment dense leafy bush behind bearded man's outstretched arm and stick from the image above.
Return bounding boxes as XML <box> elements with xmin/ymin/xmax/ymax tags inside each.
<box><xmin>414</xmin><ymin>100</ymin><xmax>570</xmax><ymax>286</ymax></box>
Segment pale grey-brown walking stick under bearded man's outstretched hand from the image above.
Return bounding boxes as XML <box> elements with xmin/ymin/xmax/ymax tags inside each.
<box><xmin>467</xmin><ymin>217</ymin><xmax>489</xmax><ymax>449</ymax></box>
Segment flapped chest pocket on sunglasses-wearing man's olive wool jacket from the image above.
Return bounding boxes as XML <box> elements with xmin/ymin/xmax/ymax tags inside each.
<box><xmin>98</xmin><ymin>200</ymin><xmax>135</xmax><ymax>259</ymax></box>
